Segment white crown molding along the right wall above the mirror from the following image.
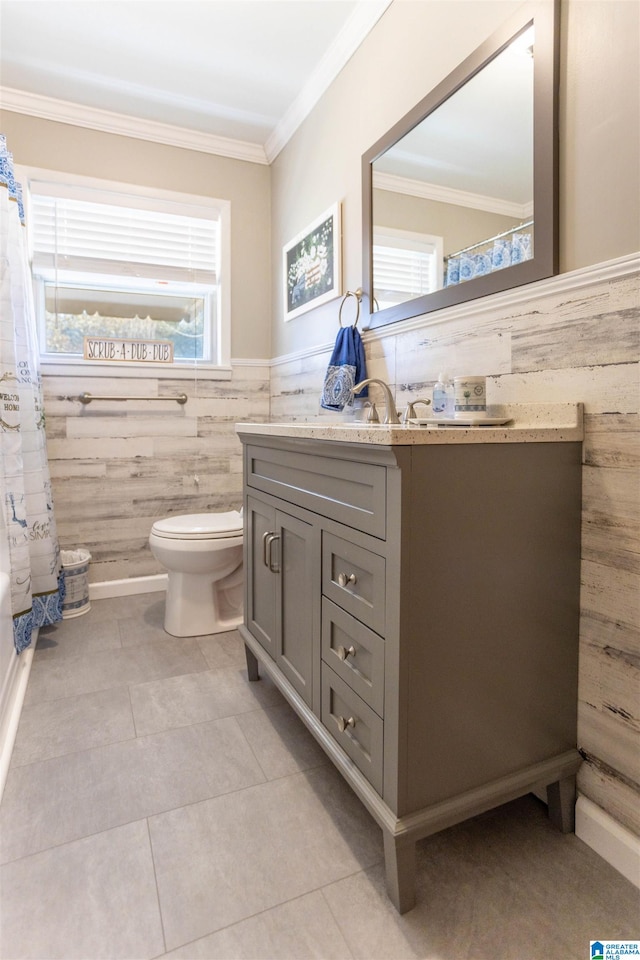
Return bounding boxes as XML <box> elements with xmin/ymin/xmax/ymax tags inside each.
<box><xmin>265</xmin><ymin>0</ymin><xmax>393</xmax><ymax>163</ymax></box>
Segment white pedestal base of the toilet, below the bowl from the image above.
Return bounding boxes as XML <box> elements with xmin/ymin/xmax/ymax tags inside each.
<box><xmin>164</xmin><ymin>566</ymin><xmax>243</xmax><ymax>637</ymax></box>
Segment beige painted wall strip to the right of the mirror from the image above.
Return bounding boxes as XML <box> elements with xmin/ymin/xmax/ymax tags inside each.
<box><xmin>560</xmin><ymin>0</ymin><xmax>640</xmax><ymax>272</ymax></box>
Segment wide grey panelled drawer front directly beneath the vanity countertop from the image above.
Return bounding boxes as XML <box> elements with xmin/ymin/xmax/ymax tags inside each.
<box><xmin>245</xmin><ymin>444</ymin><xmax>387</xmax><ymax>538</ymax></box>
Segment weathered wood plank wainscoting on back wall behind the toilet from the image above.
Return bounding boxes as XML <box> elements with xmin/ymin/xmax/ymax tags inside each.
<box><xmin>43</xmin><ymin>361</ymin><xmax>269</xmax><ymax>583</ymax></box>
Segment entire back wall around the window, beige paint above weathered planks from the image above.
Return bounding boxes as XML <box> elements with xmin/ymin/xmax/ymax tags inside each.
<box><xmin>0</xmin><ymin>111</ymin><xmax>271</xmax><ymax>582</ymax></box>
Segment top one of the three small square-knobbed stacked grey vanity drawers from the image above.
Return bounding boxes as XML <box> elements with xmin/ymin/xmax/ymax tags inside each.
<box><xmin>322</xmin><ymin>530</ymin><xmax>386</xmax><ymax>636</ymax></box>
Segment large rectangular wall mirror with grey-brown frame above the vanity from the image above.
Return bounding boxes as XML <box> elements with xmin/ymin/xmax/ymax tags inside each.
<box><xmin>362</xmin><ymin>0</ymin><xmax>559</xmax><ymax>327</ymax></box>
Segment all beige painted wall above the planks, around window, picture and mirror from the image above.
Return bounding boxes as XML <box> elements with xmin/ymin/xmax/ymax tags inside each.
<box><xmin>0</xmin><ymin>0</ymin><xmax>640</xmax><ymax>358</ymax></box>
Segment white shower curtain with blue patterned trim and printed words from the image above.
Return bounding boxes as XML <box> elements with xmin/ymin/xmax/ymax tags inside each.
<box><xmin>0</xmin><ymin>135</ymin><xmax>64</xmax><ymax>653</ymax></box>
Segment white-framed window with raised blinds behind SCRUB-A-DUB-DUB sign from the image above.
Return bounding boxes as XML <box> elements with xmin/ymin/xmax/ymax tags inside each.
<box><xmin>28</xmin><ymin>175</ymin><xmax>229</xmax><ymax>375</ymax></box>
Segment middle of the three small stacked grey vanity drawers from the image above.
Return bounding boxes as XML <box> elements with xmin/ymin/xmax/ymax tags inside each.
<box><xmin>322</xmin><ymin>597</ymin><xmax>384</xmax><ymax>717</ymax></box>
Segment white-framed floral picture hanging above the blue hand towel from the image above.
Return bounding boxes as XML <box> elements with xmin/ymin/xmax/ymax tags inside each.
<box><xmin>282</xmin><ymin>203</ymin><xmax>342</xmax><ymax>322</ymax></box>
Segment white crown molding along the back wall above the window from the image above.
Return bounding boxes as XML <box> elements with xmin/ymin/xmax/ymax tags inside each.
<box><xmin>0</xmin><ymin>87</ymin><xmax>268</xmax><ymax>164</ymax></box>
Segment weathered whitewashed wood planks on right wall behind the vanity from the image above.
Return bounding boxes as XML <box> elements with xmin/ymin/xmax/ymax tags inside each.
<box><xmin>271</xmin><ymin>256</ymin><xmax>640</xmax><ymax>883</ymax></box>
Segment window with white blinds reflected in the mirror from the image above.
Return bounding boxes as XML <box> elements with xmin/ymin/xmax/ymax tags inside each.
<box><xmin>373</xmin><ymin>227</ymin><xmax>442</xmax><ymax>310</ymax></box>
